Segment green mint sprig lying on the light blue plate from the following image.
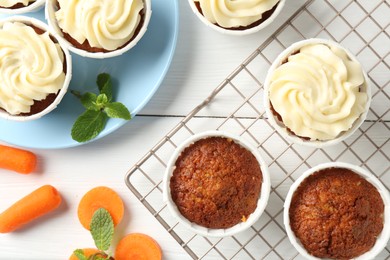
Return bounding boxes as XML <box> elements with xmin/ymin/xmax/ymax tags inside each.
<box><xmin>71</xmin><ymin>73</ymin><xmax>131</xmax><ymax>143</ymax></box>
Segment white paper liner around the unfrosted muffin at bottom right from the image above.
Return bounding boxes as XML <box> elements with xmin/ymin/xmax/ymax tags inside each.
<box><xmin>283</xmin><ymin>162</ymin><xmax>390</xmax><ymax>260</ymax></box>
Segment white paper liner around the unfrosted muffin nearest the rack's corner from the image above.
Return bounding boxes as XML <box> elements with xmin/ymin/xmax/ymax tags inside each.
<box><xmin>163</xmin><ymin>131</ymin><xmax>271</xmax><ymax>237</ymax></box>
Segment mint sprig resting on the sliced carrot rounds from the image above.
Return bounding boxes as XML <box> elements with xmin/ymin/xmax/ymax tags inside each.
<box><xmin>73</xmin><ymin>208</ymin><xmax>114</xmax><ymax>260</ymax></box>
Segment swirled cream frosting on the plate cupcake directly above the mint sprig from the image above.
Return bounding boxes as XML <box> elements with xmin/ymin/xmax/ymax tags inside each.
<box><xmin>55</xmin><ymin>0</ymin><xmax>144</xmax><ymax>51</ymax></box>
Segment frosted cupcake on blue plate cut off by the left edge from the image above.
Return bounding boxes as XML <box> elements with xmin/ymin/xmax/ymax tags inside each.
<box><xmin>0</xmin><ymin>16</ymin><xmax>71</xmax><ymax>121</ymax></box>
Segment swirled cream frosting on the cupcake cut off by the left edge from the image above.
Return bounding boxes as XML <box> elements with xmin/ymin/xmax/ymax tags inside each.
<box><xmin>0</xmin><ymin>22</ymin><xmax>65</xmax><ymax>115</ymax></box>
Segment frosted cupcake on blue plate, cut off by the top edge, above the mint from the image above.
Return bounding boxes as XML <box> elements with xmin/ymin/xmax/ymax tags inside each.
<box><xmin>46</xmin><ymin>0</ymin><xmax>151</xmax><ymax>58</ymax></box>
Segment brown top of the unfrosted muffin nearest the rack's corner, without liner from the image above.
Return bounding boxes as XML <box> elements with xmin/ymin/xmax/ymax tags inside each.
<box><xmin>170</xmin><ymin>136</ymin><xmax>263</xmax><ymax>229</ymax></box>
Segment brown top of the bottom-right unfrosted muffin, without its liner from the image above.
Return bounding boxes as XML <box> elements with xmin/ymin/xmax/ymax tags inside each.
<box><xmin>289</xmin><ymin>168</ymin><xmax>384</xmax><ymax>259</ymax></box>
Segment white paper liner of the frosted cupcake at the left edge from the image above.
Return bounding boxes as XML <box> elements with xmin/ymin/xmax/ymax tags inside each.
<box><xmin>0</xmin><ymin>16</ymin><xmax>72</xmax><ymax>121</ymax></box>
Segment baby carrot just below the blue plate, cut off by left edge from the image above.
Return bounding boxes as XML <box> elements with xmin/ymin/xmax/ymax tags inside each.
<box><xmin>0</xmin><ymin>145</ymin><xmax>37</xmax><ymax>174</ymax></box>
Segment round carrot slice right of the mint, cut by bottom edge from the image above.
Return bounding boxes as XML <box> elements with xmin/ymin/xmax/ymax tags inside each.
<box><xmin>115</xmin><ymin>233</ymin><xmax>162</xmax><ymax>260</ymax></box>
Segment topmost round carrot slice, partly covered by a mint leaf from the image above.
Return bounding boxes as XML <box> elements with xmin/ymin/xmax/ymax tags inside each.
<box><xmin>77</xmin><ymin>186</ymin><xmax>124</xmax><ymax>230</ymax></box>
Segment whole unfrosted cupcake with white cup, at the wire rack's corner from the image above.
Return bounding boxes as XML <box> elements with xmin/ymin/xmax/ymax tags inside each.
<box><xmin>163</xmin><ymin>131</ymin><xmax>270</xmax><ymax>237</ymax></box>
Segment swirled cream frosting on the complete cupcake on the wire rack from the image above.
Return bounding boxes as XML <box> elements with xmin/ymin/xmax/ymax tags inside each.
<box><xmin>269</xmin><ymin>44</ymin><xmax>368</xmax><ymax>140</ymax></box>
